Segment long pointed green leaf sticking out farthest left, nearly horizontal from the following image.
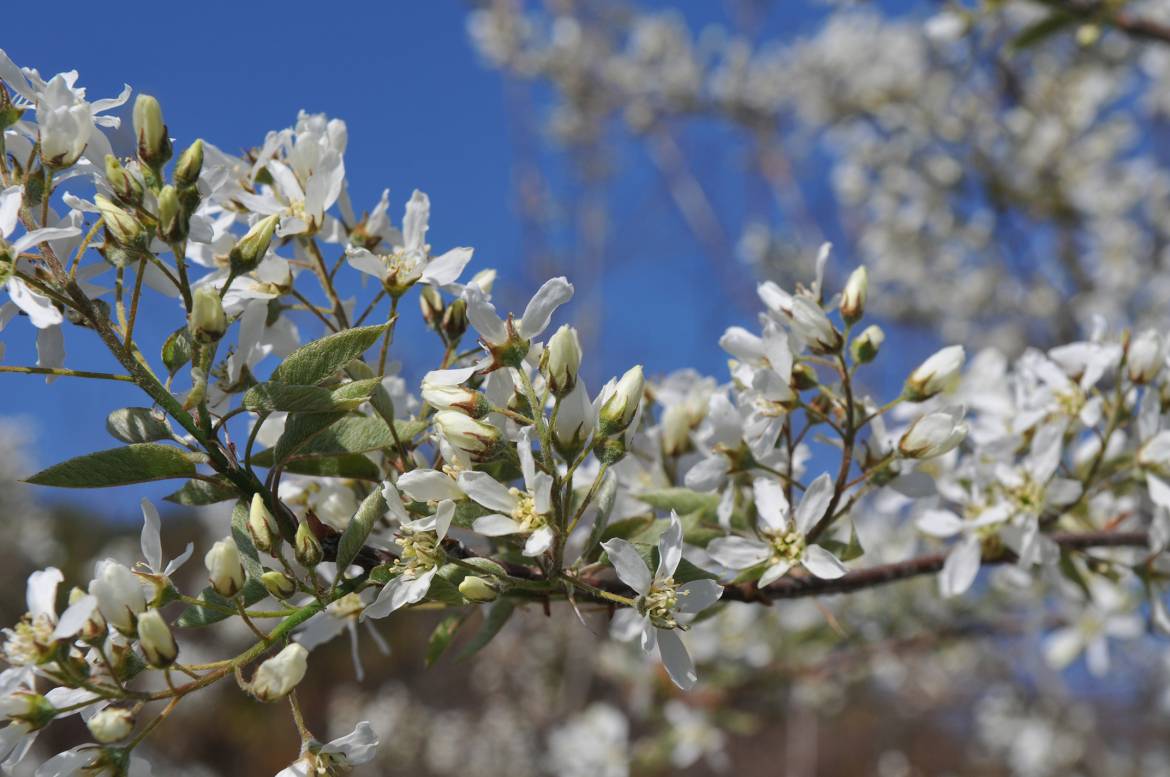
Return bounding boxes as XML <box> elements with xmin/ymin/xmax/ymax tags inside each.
<box><xmin>26</xmin><ymin>442</ymin><xmax>195</xmax><ymax>488</ymax></box>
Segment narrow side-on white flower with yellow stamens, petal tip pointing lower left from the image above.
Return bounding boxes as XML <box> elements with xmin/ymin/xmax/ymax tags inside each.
<box><xmin>360</xmin><ymin>500</ymin><xmax>455</xmax><ymax>620</ymax></box>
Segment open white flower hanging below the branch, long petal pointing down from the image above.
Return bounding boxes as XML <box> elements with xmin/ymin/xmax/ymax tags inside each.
<box><xmin>603</xmin><ymin>513</ymin><xmax>723</xmax><ymax>690</ymax></box>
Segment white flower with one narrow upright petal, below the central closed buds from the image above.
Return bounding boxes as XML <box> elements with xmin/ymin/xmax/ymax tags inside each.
<box><xmin>459</xmin><ymin>427</ymin><xmax>556</xmax><ymax>557</ymax></box>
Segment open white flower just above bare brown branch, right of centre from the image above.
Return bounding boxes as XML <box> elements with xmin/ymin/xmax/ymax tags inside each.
<box><xmin>707</xmin><ymin>473</ymin><xmax>847</xmax><ymax>587</ymax></box>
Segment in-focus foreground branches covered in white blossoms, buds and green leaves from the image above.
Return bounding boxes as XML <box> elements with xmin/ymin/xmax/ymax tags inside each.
<box><xmin>0</xmin><ymin>40</ymin><xmax>1170</xmax><ymax>777</ymax></box>
